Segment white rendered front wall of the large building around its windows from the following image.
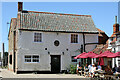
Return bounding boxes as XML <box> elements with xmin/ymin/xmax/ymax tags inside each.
<box><xmin>17</xmin><ymin>31</ymin><xmax>98</xmax><ymax>71</ymax></box>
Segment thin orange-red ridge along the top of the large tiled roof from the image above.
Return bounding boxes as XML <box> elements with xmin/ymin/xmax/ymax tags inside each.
<box><xmin>23</xmin><ymin>11</ymin><xmax>91</xmax><ymax>17</ymax></box>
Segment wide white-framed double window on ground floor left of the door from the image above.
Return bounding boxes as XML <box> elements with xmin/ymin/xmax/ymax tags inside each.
<box><xmin>24</xmin><ymin>55</ymin><xmax>40</xmax><ymax>63</ymax></box>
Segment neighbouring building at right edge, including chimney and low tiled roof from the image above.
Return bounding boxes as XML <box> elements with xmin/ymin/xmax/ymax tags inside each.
<box><xmin>92</xmin><ymin>16</ymin><xmax>120</xmax><ymax>68</ymax></box>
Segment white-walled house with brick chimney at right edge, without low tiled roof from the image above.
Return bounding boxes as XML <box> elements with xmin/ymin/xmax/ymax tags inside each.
<box><xmin>108</xmin><ymin>16</ymin><xmax>120</xmax><ymax>67</ymax></box>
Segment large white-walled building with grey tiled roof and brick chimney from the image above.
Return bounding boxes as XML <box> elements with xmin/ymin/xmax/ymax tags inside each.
<box><xmin>8</xmin><ymin>2</ymin><xmax>99</xmax><ymax>72</ymax></box>
